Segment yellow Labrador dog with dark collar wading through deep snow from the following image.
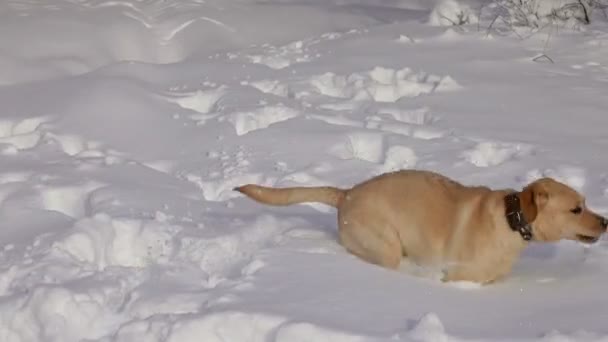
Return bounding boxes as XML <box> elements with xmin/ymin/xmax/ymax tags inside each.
<box><xmin>234</xmin><ymin>170</ymin><xmax>608</xmax><ymax>284</ymax></box>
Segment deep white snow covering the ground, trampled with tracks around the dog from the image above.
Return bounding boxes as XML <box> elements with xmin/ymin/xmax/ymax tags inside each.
<box><xmin>0</xmin><ymin>0</ymin><xmax>608</xmax><ymax>342</ymax></box>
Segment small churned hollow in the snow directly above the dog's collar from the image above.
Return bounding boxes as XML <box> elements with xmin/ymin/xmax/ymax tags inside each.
<box><xmin>463</xmin><ymin>141</ymin><xmax>533</xmax><ymax>167</ymax></box>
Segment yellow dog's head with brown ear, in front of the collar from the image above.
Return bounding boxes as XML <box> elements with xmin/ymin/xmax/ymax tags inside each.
<box><xmin>519</xmin><ymin>178</ymin><xmax>608</xmax><ymax>243</ymax></box>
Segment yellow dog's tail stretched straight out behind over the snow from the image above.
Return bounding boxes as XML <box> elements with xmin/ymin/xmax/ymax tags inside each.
<box><xmin>234</xmin><ymin>184</ymin><xmax>346</xmax><ymax>208</ymax></box>
